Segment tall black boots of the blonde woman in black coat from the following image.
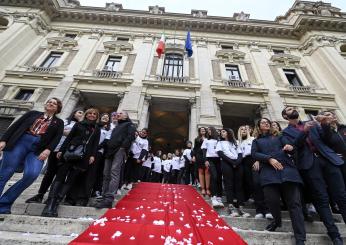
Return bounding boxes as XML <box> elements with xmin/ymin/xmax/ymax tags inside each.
<box><xmin>41</xmin><ymin>181</ymin><xmax>62</xmax><ymax>217</ymax></box>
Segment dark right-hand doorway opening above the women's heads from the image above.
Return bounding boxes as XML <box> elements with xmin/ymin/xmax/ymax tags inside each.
<box><xmin>221</xmin><ymin>103</ymin><xmax>261</xmax><ymax>135</ymax></box>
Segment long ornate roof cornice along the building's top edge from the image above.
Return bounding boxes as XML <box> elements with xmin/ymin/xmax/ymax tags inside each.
<box><xmin>0</xmin><ymin>0</ymin><xmax>346</xmax><ymax>39</ymax></box>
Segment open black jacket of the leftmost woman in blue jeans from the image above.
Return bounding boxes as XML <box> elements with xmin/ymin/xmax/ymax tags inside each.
<box><xmin>0</xmin><ymin>111</ymin><xmax>64</xmax><ymax>154</ymax></box>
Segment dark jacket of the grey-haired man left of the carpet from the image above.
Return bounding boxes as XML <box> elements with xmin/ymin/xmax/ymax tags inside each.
<box><xmin>106</xmin><ymin>119</ymin><xmax>136</xmax><ymax>158</ymax></box>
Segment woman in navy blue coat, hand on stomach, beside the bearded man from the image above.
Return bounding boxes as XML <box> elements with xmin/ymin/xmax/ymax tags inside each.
<box><xmin>251</xmin><ymin>118</ymin><xmax>306</xmax><ymax>244</ymax></box>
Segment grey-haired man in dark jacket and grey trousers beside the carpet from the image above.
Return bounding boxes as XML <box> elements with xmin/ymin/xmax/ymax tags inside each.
<box><xmin>95</xmin><ymin>111</ymin><xmax>136</xmax><ymax>208</ymax></box>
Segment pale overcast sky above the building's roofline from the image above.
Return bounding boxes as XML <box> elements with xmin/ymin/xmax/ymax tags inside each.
<box><xmin>80</xmin><ymin>0</ymin><xmax>346</xmax><ymax>20</ymax></box>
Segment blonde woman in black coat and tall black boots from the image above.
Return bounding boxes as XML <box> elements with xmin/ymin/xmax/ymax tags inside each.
<box><xmin>42</xmin><ymin>108</ymin><xmax>100</xmax><ymax>217</ymax></box>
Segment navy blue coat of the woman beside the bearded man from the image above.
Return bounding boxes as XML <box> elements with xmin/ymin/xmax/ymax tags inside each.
<box><xmin>251</xmin><ymin>134</ymin><xmax>303</xmax><ymax>186</ymax></box>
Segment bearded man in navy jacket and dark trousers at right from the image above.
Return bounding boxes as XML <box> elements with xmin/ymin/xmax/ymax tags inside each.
<box><xmin>282</xmin><ymin>106</ymin><xmax>346</xmax><ymax>245</ymax></box>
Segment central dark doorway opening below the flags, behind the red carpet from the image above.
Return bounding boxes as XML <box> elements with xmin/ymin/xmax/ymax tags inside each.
<box><xmin>149</xmin><ymin>98</ymin><xmax>190</xmax><ymax>153</ymax></box>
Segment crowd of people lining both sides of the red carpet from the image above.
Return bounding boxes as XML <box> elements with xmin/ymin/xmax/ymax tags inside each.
<box><xmin>0</xmin><ymin>98</ymin><xmax>346</xmax><ymax>245</ymax></box>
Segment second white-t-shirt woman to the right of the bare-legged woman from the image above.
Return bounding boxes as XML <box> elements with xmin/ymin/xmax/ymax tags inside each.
<box><xmin>216</xmin><ymin>129</ymin><xmax>250</xmax><ymax>217</ymax></box>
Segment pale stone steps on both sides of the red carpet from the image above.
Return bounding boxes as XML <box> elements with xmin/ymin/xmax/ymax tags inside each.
<box><xmin>0</xmin><ymin>174</ymin><xmax>346</xmax><ymax>245</ymax></box>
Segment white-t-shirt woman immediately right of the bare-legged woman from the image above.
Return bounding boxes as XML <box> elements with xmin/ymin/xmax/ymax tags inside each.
<box><xmin>201</xmin><ymin>127</ymin><xmax>224</xmax><ymax>207</ymax></box>
